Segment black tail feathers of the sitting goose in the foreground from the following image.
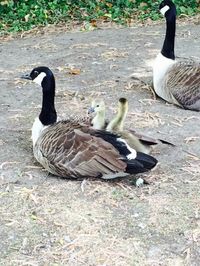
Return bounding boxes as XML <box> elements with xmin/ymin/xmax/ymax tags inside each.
<box><xmin>124</xmin><ymin>152</ymin><xmax>158</xmax><ymax>174</ymax></box>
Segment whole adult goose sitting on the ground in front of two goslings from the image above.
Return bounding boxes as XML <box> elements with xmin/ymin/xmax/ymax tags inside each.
<box><xmin>22</xmin><ymin>67</ymin><xmax>157</xmax><ymax>179</ymax></box>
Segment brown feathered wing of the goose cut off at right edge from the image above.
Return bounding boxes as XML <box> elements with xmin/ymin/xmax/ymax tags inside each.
<box><xmin>165</xmin><ymin>62</ymin><xmax>200</xmax><ymax>110</ymax></box>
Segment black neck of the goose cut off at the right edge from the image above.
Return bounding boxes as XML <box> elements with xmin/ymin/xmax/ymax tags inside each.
<box><xmin>161</xmin><ymin>15</ymin><xmax>176</xmax><ymax>60</ymax></box>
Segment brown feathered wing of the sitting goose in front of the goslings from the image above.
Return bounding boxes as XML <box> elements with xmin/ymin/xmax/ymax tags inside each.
<box><xmin>37</xmin><ymin>121</ymin><xmax>127</xmax><ymax>178</ymax></box>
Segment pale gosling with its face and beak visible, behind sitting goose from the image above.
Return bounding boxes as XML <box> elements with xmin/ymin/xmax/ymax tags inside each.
<box><xmin>88</xmin><ymin>99</ymin><xmax>107</xmax><ymax>129</ymax></box>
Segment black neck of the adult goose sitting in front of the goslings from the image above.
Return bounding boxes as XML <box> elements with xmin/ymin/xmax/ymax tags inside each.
<box><xmin>39</xmin><ymin>76</ymin><xmax>57</xmax><ymax>126</ymax></box>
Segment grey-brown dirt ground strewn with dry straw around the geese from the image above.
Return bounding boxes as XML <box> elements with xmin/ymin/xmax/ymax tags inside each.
<box><xmin>0</xmin><ymin>22</ymin><xmax>200</xmax><ymax>266</ymax></box>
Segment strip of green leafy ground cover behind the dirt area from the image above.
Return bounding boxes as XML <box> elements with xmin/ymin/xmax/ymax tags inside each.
<box><xmin>0</xmin><ymin>0</ymin><xmax>200</xmax><ymax>33</ymax></box>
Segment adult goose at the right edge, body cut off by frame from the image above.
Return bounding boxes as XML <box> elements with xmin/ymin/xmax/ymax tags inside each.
<box><xmin>153</xmin><ymin>0</ymin><xmax>200</xmax><ymax>111</ymax></box>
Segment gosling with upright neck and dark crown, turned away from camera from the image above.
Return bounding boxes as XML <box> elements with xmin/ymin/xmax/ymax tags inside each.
<box><xmin>106</xmin><ymin>98</ymin><xmax>174</xmax><ymax>154</ymax></box>
